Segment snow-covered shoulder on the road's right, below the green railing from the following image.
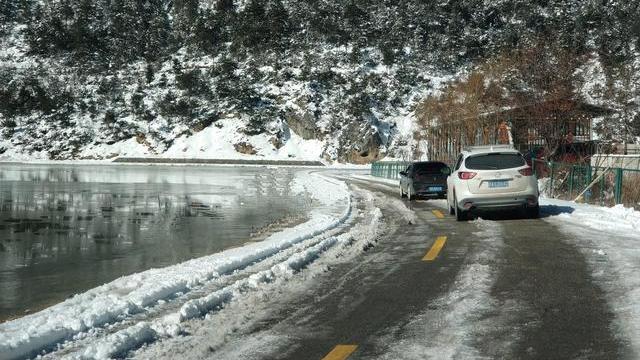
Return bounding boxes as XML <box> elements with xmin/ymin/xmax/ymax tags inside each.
<box><xmin>541</xmin><ymin>199</ymin><xmax>640</xmax><ymax>355</ymax></box>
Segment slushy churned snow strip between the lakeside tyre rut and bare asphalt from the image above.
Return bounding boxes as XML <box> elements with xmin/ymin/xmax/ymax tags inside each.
<box><xmin>134</xmin><ymin>184</ymin><xmax>385</xmax><ymax>360</ymax></box>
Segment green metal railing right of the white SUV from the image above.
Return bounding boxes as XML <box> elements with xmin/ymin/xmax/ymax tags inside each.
<box><xmin>533</xmin><ymin>159</ymin><xmax>640</xmax><ymax>208</ymax></box>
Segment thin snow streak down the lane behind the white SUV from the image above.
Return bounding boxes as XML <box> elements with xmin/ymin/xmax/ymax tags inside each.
<box><xmin>378</xmin><ymin>220</ymin><xmax>508</xmax><ymax>359</ymax></box>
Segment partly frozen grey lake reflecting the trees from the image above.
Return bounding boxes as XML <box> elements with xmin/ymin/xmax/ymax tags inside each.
<box><xmin>0</xmin><ymin>164</ymin><xmax>311</xmax><ymax>321</ymax></box>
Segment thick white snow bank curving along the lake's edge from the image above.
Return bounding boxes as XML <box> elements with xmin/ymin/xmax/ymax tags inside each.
<box><xmin>0</xmin><ymin>172</ymin><xmax>351</xmax><ymax>359</ymax></box>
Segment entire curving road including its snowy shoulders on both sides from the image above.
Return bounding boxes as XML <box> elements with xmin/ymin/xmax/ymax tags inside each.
<box><xmin>0</xmin><ymin>170</ymin><xmax>640</xmax><ymax>359</ymax></box>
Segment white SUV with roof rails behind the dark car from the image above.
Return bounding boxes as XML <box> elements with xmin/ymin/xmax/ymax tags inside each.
<box><xmin>447</xmin><ymin>145</ymin><xmax>540</xmax><ymax>221</ymax></box>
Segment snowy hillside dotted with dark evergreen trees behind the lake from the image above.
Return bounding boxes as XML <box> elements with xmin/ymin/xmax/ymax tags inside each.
<box><xmin>0</xmin><ymin>0</ymin><xmax>640</xmax><ymax>163</ymax></box>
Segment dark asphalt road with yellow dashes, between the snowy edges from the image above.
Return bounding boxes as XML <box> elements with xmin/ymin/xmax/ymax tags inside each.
<box><xmin>212</xmin><ymin>179</ymin><xmax>635</xmax><ymax>359</ymax></box>
